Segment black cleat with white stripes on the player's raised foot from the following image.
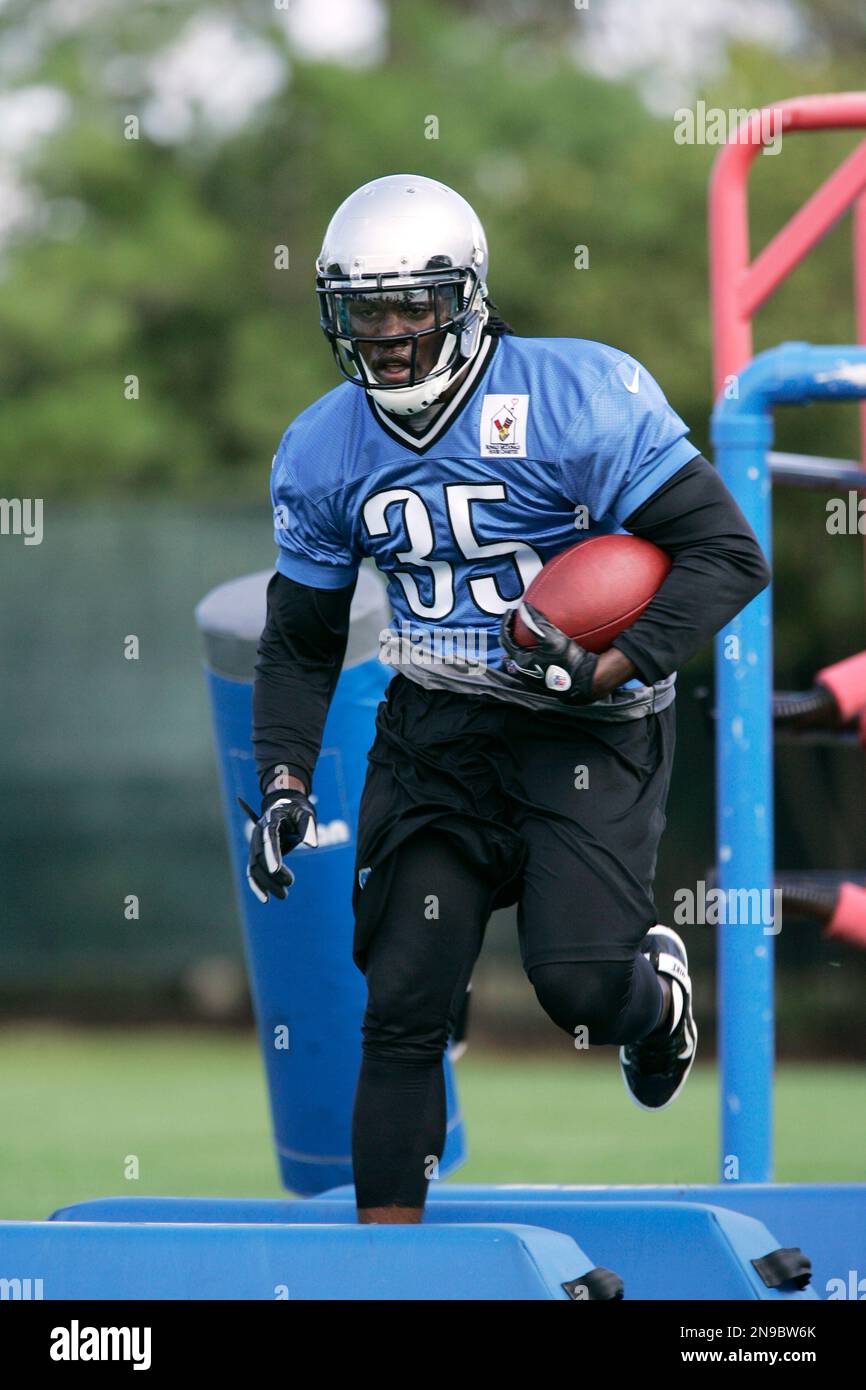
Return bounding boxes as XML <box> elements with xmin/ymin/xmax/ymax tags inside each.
<box><xmin>620</xmin><ymin>926</ymin><xmax>698</xmax><ymax>1111</ymax></box>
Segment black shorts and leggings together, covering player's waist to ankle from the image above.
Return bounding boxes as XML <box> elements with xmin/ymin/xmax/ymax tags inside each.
<box><xmin>352</xmin><ymin>676</ymin><xmax>676</xmax><ymax>1208</ymax></box>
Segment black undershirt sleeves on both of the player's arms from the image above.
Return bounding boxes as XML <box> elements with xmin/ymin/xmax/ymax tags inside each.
<box><xmin>253</xmin><ymin>455</ymin><xmax>770</xmax><ymax>791</ymax></box>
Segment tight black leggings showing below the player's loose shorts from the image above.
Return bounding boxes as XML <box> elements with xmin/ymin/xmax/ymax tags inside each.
<box><xmin>352</xmin><ymin>827</ymin><xmax>663</xmax><ymax>1208</ymax></box>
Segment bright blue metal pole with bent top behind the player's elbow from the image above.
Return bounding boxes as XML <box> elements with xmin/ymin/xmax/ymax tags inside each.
<box><xmin>712</xmin><ymin>343</ymin><xmax>866</xmax><ymax>1183</ymax></box>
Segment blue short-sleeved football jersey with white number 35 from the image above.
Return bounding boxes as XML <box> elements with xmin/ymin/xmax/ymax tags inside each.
<box><xmin>271</xmin><ymin>335</ymin><xmax>701</xmax><ymax>717</ymax></box>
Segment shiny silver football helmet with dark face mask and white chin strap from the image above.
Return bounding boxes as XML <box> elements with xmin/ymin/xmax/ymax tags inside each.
<box><xmin>316</xmin><ymin>174</ymin><xmax>488</xmax><ymax>416</ymax></box>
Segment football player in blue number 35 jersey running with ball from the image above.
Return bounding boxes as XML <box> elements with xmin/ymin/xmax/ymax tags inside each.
<box><xmin>249</xmin><ymin>175</ymin><xmax>770</xmax><ymax>1222</ymax></box>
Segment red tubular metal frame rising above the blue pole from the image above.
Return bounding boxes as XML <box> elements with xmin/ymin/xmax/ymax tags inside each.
<box><xmin>709</xmin><ymin>92</ymin><xmax>866</xmax><ymax>467</ymax></box>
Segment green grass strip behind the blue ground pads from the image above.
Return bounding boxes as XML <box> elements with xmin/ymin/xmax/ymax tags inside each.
<box><xmin>0</xmin><ymin>1024</ymin><xmax>866</xmax><ymax>1220</ymax></box>
